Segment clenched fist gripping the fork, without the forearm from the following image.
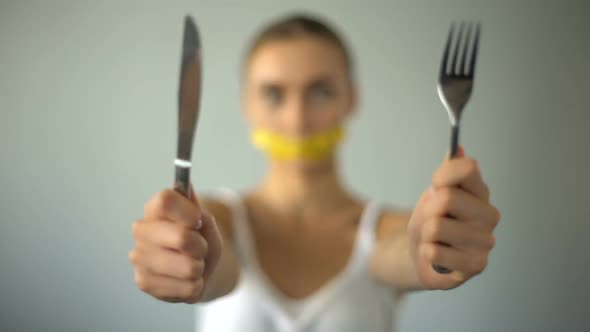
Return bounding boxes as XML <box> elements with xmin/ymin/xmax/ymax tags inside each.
<box><xmin>408</xmin><ymin>148</ymin><xmax>500</xmax><ymax>289</ymax></box>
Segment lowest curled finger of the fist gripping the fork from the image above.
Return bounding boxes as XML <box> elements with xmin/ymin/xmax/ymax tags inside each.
<box><xmin>421</xmin><ymin>243</ymin><xmax>487</xmax><ymax>277</ymax></box>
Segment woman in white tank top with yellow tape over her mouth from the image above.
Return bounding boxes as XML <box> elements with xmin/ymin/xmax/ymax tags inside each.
<box><xmin>130</xmin><ymin>16</ymin><xmax>500</xmax><ymax>332</ymax></box>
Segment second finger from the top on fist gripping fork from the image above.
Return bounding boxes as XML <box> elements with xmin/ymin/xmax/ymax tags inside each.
<box><xmin>427</xmin><ymin>187</ymin><xmax>499</xmax><ymax>229</ymax></box>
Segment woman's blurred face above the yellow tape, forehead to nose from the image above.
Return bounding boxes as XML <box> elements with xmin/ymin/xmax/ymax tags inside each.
<box><xmin>243</xmin><ymin>37</ymin><xmax>355</xmax><ymax>143</ymax></box>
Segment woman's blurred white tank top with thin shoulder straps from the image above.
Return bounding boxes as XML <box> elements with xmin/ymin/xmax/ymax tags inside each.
<box><xmin>195</xmin><ymin>189</ymin><xmax>399</xmax><ymax>332</ymax></box>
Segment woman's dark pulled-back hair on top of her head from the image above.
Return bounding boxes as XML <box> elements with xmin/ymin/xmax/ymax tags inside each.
<box><xmin>243</xmin><ymin>13</ymin><xmax>353</xmax><ymax>77</ymax></box>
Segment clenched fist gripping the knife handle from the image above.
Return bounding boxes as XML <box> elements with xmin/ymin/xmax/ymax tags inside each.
<box><xmin>129</xmin><ymin>187</ymin><xmax>222</xmax><ymax>303</ymax></box>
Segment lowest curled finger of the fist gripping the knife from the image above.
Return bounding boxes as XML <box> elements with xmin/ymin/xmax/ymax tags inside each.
<box><xmin>135</xmin><ymin>269</ymin><xmax>203</xmax><ymax>302</ymax></box>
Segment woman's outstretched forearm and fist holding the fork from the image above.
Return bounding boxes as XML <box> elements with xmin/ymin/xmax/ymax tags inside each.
<box><xmin>371</xmin><ymin>148</ymin><xmax>500</xmax><ymax>290</ymax></box>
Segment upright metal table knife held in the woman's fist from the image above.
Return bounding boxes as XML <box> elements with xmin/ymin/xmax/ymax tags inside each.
<box><xmin>174</xmin><ymin>15</ymin><xmax>202</xmax><ymax>198</ymax></box>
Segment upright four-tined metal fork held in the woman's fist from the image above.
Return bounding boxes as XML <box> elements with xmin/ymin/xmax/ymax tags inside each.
<box><xmin>433</xmin><ymin>23</ymin><xmax>481</xmax><ymax>274</ymax></box>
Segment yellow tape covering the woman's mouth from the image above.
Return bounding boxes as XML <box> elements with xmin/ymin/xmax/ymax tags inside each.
<box><xmin>252</xmin><ymin>127</ymin><xmax>344</xmax><ymax>161</ymax></box>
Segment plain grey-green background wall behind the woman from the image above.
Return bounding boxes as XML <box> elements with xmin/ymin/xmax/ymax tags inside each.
<box><xmin>0</xmin><ymin>0</ymin><xmax>590</xmax><ymax>332</ymax></box>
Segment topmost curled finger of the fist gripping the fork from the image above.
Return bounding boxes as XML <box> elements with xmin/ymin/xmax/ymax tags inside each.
<box><xmin>432</xmin><ymin>157</ymin><xmax>490</xmax><ymax>201</ymax></box>
